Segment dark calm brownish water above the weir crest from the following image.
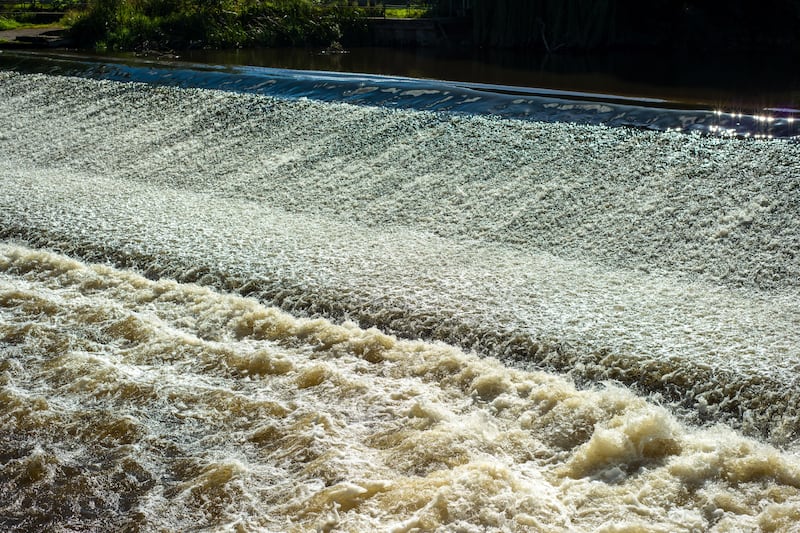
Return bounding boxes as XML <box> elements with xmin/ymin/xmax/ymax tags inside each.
<box><xmin>179</xmin><ymin>47</ymin><xmax>800</xmax><ymax>112</ymax></box>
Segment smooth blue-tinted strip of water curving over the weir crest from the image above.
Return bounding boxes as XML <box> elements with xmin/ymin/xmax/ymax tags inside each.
<box><xmin>0</xmin><ymin>52</ymin><xmax>800</xmax><ymax>140</ymax></box>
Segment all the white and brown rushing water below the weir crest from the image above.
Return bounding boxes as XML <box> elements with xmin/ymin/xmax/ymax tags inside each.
<box><xmin>0</xmin><ymin>61</ymin><xmax>800</xmax><ymax>531</ymax></box>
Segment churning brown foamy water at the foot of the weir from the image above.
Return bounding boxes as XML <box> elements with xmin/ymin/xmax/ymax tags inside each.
<box><xmin>0</xmin><ymin>244</ymin><xmax>800</xmax><ymax>531</ymax></box>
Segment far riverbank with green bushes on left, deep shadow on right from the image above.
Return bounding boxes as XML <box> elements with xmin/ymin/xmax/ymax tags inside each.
<box><xmin>6</xmin><ymin>0</ymin><xmax>800</xmax><ymax>55</ymax></box>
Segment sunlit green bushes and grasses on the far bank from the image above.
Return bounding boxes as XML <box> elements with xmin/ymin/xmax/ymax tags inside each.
<box><xmin>65</xmin><ymin>0</ymin><xmax>367</xmax><ymax>50</ymax></box>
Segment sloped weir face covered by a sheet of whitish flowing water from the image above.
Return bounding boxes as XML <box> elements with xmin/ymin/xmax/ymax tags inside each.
<box><xmin>0</xmin><ymin>67</ymin><xmax>800</xmax><ymax>444</ymax></box>
